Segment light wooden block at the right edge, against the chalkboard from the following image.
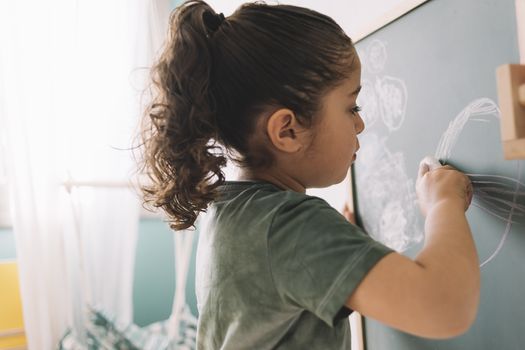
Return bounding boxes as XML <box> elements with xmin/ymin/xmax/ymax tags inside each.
<box><xmin>496</xmin><ymin>64</ymin><xmax>525</xmax><ymax>141</ymax></box>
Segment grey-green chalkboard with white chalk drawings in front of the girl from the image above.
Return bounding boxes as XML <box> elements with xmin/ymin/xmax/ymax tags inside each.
<box><xmin>353</xmin><ymin>0</ymin><xmax>525</xmax><ymax>350</ymax></box>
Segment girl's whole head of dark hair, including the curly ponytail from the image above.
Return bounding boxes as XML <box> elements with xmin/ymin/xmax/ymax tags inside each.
<box><xmin>137</xmin><ymin>0</ymin><xmax>356</xmax><ymax>230</ymax></box>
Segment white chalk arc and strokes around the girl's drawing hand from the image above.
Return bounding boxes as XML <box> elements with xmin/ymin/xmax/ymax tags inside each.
<box><xmin>435</xmin><ymin>98</ymin><xmax>525</xmax><ymax>267</ymax></box>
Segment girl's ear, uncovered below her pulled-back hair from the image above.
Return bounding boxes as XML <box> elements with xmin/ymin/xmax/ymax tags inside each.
<box><xmin>266</xmin><ymin>108</ymin><xmax>305</xmax><ymax>153</ymax></box>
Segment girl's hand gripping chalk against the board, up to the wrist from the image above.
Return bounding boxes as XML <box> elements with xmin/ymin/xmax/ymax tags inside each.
<box><xmin>416</xmin><ymin>158</ymin><xmax>473</xmax><ymax>216</ymax></box>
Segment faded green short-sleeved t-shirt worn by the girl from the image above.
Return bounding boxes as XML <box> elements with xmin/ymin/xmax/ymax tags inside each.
<box><xmin>196</xmin><ymin>181</ymin><xmax>392</xmax><ymax>350</ymax></box>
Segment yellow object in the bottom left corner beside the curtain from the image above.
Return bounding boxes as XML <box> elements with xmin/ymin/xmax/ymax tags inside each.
<box><xmin>0</xmin><ymin>262</ymin><xmax>27</xmax><ymax>350</ymax></box>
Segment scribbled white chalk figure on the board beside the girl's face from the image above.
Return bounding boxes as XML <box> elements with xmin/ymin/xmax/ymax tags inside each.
<box><xmin>356</xmin><ymin>40</ymin><xmax>423</xmax><ymax>251</ymax></box>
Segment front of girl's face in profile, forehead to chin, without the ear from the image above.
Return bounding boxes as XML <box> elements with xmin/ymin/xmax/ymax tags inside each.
<box><xmin>298</xmin><ymin>56</ymin><xmax>365</xmax><ymax>187</ymax></box>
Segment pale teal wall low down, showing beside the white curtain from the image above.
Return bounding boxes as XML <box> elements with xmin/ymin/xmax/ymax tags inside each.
<box><xmin>0</xmin><ymin>219</ymin><xmax>197</xmax><ymax>326</ymax></box>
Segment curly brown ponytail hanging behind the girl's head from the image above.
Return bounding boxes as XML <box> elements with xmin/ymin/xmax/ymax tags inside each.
<box><xmin>141</xmin><ymin>0</ymin><xmax>226</xmax><ymax>230</ymax></box>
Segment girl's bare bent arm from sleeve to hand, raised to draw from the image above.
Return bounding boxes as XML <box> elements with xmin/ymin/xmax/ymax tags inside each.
<box><xmin>346</xmin><ymin>162</ymin><xmax>480</xmax><ymax>338</ymax></box>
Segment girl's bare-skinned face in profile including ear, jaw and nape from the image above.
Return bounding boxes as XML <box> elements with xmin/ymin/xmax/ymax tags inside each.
<box><xmin>240</xmin><ymin>54</ymin><xmax>365</xmax><ymax>192</ymax></box>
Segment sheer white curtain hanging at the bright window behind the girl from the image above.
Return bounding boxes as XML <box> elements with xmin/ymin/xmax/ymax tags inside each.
<box><xmin>0</xmin><ymin>0</ymin><xmax>170</xmax><ymax>350</ymax></box>
